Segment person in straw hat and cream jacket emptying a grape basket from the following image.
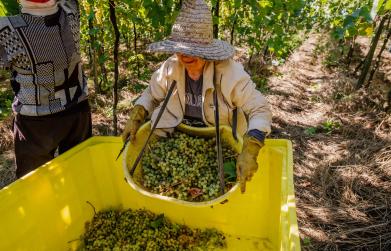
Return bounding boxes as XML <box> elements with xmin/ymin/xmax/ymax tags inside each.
<box><xmin>122</xmin><ymin>0</ymin><xmax>272</xmax><ymax>192</ymax></box>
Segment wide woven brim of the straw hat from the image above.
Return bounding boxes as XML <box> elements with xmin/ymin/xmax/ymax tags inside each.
<box><xmin>148</xmin><ymin>39</ymin><xmax>235</xmax><ymax>61</ymax></box>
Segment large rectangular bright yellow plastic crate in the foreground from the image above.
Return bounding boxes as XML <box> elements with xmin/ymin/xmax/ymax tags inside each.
<box><xmin>0</xmin><ymin>131</ymin><xmax>300</xmax><ymax>251</ymax></box>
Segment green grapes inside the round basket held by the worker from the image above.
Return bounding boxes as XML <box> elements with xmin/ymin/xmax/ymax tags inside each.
<box><xmin>139</xmin><ymin>131</ymin><xmax>237</xmax><ymax>201</ymax></box>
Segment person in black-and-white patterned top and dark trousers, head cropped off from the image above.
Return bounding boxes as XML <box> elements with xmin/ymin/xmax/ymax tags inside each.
<box><xmin>0</xmin><ymin>0</ymin><xmax>92</xmax><ymax>178</ymax></box>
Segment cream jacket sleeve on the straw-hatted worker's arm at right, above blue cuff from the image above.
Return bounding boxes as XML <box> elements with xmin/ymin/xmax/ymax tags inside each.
<box><xmin>231</xmin><ymin>67</ymin><xmax>272</xmax><ymax>134</ymax></box>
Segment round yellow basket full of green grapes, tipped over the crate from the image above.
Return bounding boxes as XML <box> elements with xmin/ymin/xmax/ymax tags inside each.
<box><xmin>123</xmin><ymin>123</ymin><xmax>242</xmax><ymax>206</ymax></box>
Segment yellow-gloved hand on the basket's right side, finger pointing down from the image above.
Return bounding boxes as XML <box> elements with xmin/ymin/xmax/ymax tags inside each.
<box><xmin>236</xmin><ymin>135</ymin><xmax>264</xmax><ymax>193</ymax></box>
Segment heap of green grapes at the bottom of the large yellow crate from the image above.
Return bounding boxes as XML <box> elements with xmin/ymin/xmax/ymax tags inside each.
<box><xmin>78</xmin><ymin>209</ymin><xmax>226</xmax><ymax>251</ymax></box>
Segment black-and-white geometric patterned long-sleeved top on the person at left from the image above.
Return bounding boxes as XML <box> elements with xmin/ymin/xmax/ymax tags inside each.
<box><xmin>0</xmin><ymin>0</ymin><xmax>88</xmax><ymax>116</ymax></box>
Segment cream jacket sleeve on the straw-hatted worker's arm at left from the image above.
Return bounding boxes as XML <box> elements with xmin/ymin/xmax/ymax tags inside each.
<box><xmin>135</xmin><ymin>61</ymin><xmax>169</xmax><ymax>115</ymax></box>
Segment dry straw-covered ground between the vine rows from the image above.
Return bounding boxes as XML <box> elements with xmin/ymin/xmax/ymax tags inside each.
<box><xmin>0</xmin><ymin>34</ymin><xmax>391</xmax><ymax>250</ymax></box>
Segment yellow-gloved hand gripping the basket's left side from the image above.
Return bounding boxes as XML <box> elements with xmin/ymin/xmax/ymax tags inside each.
<box><xmin>122</xmin><ymin>105</ymin><xmax>147</xmax><ymax>142</ymax></box>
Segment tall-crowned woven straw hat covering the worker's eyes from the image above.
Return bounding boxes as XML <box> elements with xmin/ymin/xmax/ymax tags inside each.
<box><xmin>148</xmin><ymin>0</ymin><xmax>235</xmax><ymax>61</ymax></box>
